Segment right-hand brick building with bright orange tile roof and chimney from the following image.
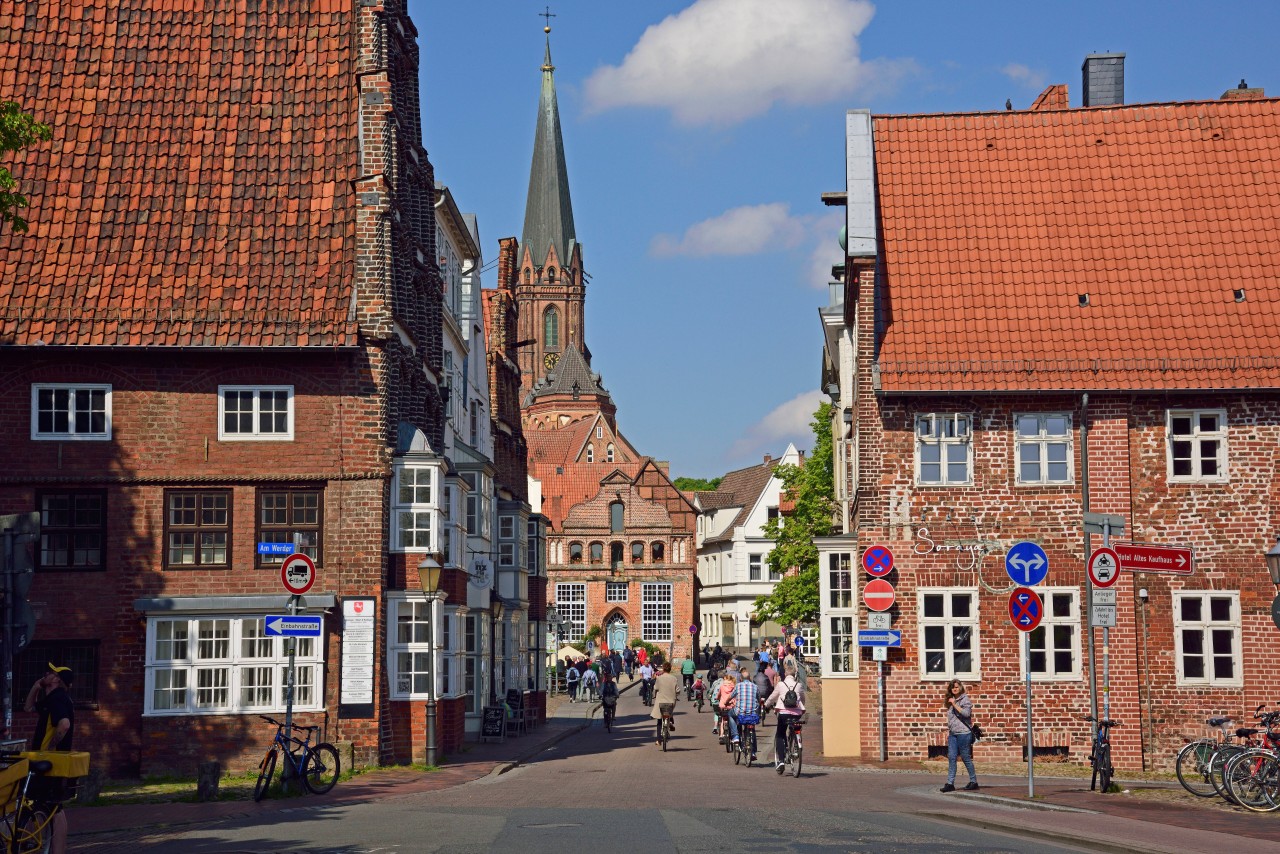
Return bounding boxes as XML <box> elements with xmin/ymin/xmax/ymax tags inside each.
<box><xmin>820</xmin><ymin>55</ymin><xmax>1280</xmax><ymax>768</ymax></box>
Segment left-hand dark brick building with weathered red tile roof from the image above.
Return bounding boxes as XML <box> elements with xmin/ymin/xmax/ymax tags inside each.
<box><xmin>0</xmin><ymin>0</ymin><xmax>467</xmax><ymax>773</ymax></box>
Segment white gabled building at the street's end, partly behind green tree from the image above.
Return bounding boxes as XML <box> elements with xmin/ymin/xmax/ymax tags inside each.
<box><xmin>694</xmin><ymin>444</ymin><xmax>804</xmax><ymax>650</ymax></box>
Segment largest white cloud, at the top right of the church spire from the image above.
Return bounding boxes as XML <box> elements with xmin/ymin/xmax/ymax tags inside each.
<box><xmin>585</xmin><ymin>0</ymin><xmax>909</xmax><ymax>125</ymax></box>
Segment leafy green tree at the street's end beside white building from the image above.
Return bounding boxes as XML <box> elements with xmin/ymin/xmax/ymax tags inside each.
<box><xmin>755</xmin><ymin>403</ymin><xmax>836</xmax><ymax>625</ymax></box>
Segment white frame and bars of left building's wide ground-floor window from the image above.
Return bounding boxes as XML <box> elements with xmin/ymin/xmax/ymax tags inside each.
<box><xmin>142</xmin><ymin>613</ymin><xmax>325</xmax><ymax>717</ymax></box>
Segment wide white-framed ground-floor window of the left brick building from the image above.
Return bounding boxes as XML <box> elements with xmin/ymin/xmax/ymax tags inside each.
<box><xmin>146</xmin><ymin>616</ymin><xmax>324</xmax><ymax>714</ymax></box>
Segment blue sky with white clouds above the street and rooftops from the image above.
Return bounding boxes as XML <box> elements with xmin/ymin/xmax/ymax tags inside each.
<box><xmin>408</xmin><ymin>0</ymin><xmax>1280</xmax><ymax>478</ymax></box>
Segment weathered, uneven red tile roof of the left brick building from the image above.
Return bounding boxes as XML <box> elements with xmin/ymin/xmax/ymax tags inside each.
<box><xmin>0</xmin><ymin>0</ymin><xmax>358</xmax><ymax>346</ymax></box>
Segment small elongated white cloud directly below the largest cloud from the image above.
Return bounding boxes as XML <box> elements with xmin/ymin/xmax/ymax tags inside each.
<box><xmin>649</xmin><ymin>202</ymin><xmax>805</xmax><ymax>257</ymax></box>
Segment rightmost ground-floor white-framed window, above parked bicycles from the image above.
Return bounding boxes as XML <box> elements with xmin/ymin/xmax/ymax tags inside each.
<box><xmin>1174</xmin><ymin>592</ymin><xmax>1242</xmax><ymax>686</ymax></box>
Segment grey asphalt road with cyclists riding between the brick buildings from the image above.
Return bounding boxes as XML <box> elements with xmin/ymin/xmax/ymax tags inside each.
<box><xmin>104</xmin><ymin>691</ymin><xmax>1105</xmax><ymax>854</ymax></box>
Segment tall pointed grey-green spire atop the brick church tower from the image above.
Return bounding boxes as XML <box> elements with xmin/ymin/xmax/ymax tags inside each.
<box><xmin>520</xmin><ymin>18</ymin><xmax>577</xmax><ymax>265</ymax></box>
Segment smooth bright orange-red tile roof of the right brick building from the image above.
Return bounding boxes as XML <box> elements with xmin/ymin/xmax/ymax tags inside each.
<box><xmin>873</xmin><ymin>99</ymin><xmax>1280</xmax><ymax>392</ymax></box>
